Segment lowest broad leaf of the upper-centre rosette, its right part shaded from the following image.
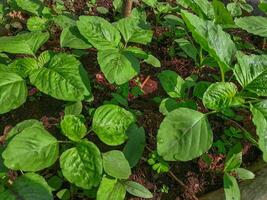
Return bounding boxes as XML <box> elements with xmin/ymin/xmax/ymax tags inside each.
<box><xmin>97</xmin><ymin>49</ymin><xmax>140</xmax><ymax>85</ymax></box>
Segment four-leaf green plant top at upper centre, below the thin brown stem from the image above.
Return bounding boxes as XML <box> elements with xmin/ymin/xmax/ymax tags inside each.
<box><xmin>77</xmin><ymin>16</ymin><xmax>160</xmax><ymax>85</ymax></box>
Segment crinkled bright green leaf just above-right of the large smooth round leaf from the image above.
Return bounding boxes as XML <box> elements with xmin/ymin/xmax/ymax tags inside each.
<box><xmin>203</xmin><ymin>82</ymin><xmax>244</xmax><ymax>110</ymax></box>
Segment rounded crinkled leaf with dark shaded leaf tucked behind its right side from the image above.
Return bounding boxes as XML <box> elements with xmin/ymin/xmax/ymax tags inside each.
<box><xmin>92</xmin><ymin>104</ymin><xmax>135</xmax><ymax>146</ymax></box>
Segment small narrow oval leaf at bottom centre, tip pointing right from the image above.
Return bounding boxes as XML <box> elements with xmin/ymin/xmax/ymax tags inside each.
<box><xmin>123</xmin><ymin>181</ymin><xmax>153</xmax><ymax>199</ymax></box>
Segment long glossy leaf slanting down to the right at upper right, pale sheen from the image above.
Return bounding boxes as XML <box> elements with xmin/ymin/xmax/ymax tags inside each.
<box><xmin>181</xmin><ymin>10</ymin><xmax>236</xmax><ymax>72</ymax></box>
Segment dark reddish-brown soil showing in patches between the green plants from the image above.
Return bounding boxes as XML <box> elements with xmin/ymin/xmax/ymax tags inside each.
<box><xmin>0</xmin><ymin>0</ymin><xmax>260</xmax><ymax>200</ymax></box>
